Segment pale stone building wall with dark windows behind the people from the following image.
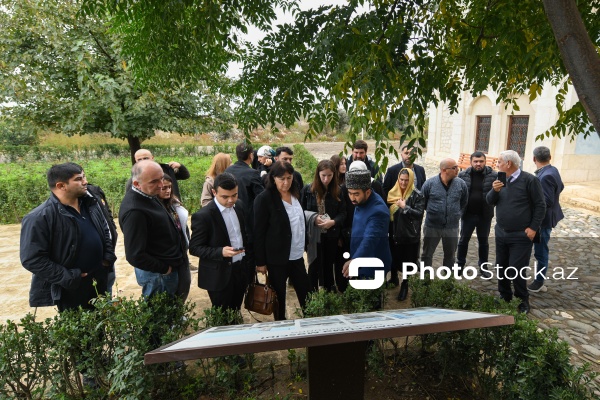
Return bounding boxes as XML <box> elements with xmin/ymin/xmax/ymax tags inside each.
<box><xmin>426</xmin><ymin>85</ymin><xmax>600</xmax><ymax>183</ymax></box>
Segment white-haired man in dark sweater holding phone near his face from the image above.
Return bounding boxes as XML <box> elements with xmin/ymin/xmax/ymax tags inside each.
<box><xmin>486</xmin><ymin>150</ymin><xmax>546</xmax><ymax>313</ymax></box>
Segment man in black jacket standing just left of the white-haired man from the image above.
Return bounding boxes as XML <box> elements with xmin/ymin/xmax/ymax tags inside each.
<box><xmin>456</xmin><ymin>151</ymin><xmax>498</xmax><ymax>276</ymax></box>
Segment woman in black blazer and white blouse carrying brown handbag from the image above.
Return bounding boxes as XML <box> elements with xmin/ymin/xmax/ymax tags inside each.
<box><xmin>254</xmin><ymin>161</ymin><xmax>311</xmax><ymax>320</ymax></box>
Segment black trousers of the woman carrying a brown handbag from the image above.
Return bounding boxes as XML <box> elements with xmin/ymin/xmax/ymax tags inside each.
<box><xmin>267</xmin><ymin>258</ymin><xmax>312</xmax><ymax>320</ymax></box>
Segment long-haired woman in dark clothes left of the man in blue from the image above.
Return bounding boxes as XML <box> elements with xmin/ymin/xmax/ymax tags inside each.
<box><xmin>300</xmin><ymin>160</ymin><xmax>346</xmax><ymax>290</ymax></box>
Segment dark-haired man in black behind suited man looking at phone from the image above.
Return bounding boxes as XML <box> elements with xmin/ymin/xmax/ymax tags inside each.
<box><xmin>225</xmin><ymin>142</ymin><xmax>265</xmax><ymax>236</ymax></box>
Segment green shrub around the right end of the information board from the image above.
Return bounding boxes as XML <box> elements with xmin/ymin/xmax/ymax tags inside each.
<box><xmin>411</xmin><ymin>279</ymin><xmax>596</xmax><ymax>400</ymax></box>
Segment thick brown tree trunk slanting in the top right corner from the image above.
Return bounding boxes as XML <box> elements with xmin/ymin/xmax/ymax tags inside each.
<box><xmin>543</xmin><ymin>0</ymin><xmax>600</xmax><ymax>135</ymax></box>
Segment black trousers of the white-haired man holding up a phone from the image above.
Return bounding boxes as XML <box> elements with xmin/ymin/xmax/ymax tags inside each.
<box><xmin>494</xmin><ymin>225</ymin><xmax>533</xmax><ymax>300</ymax></box>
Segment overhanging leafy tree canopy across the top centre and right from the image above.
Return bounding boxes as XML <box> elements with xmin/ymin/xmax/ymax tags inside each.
<box><xmin>84</xmin><ymin>0</ymin><xmax>600</xmax><ymax>162</ymax></box>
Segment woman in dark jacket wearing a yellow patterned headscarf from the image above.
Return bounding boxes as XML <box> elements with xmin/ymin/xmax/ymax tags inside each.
<box><xmin>387</xmin><ymin>168</ymin><xmax>425</xmax><ymax>301</ymax></box>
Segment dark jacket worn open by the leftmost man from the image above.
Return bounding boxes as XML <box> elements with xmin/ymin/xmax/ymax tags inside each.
<box><xmin>20</xmin><ymin>194</ymin><xmax>117</xmax><ymax>307</ymax></box>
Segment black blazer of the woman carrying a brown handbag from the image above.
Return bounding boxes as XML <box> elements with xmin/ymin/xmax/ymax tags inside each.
<box><xmin>252</xmin><ymin>189</ymin><xmax>306</xmax><ymax>266</ymax></box>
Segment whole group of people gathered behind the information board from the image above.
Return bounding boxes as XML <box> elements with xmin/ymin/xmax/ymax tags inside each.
<box><xmin>21</xmin><ymin>140</ymin><xmax>564</xmax><ymax>328</ymax></box>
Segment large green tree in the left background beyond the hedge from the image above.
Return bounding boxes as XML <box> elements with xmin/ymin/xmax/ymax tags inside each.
<box><xmin>0</xmin><ymin>0</ymin><xmax>232</xmax><ymax>162</ymax></box>
